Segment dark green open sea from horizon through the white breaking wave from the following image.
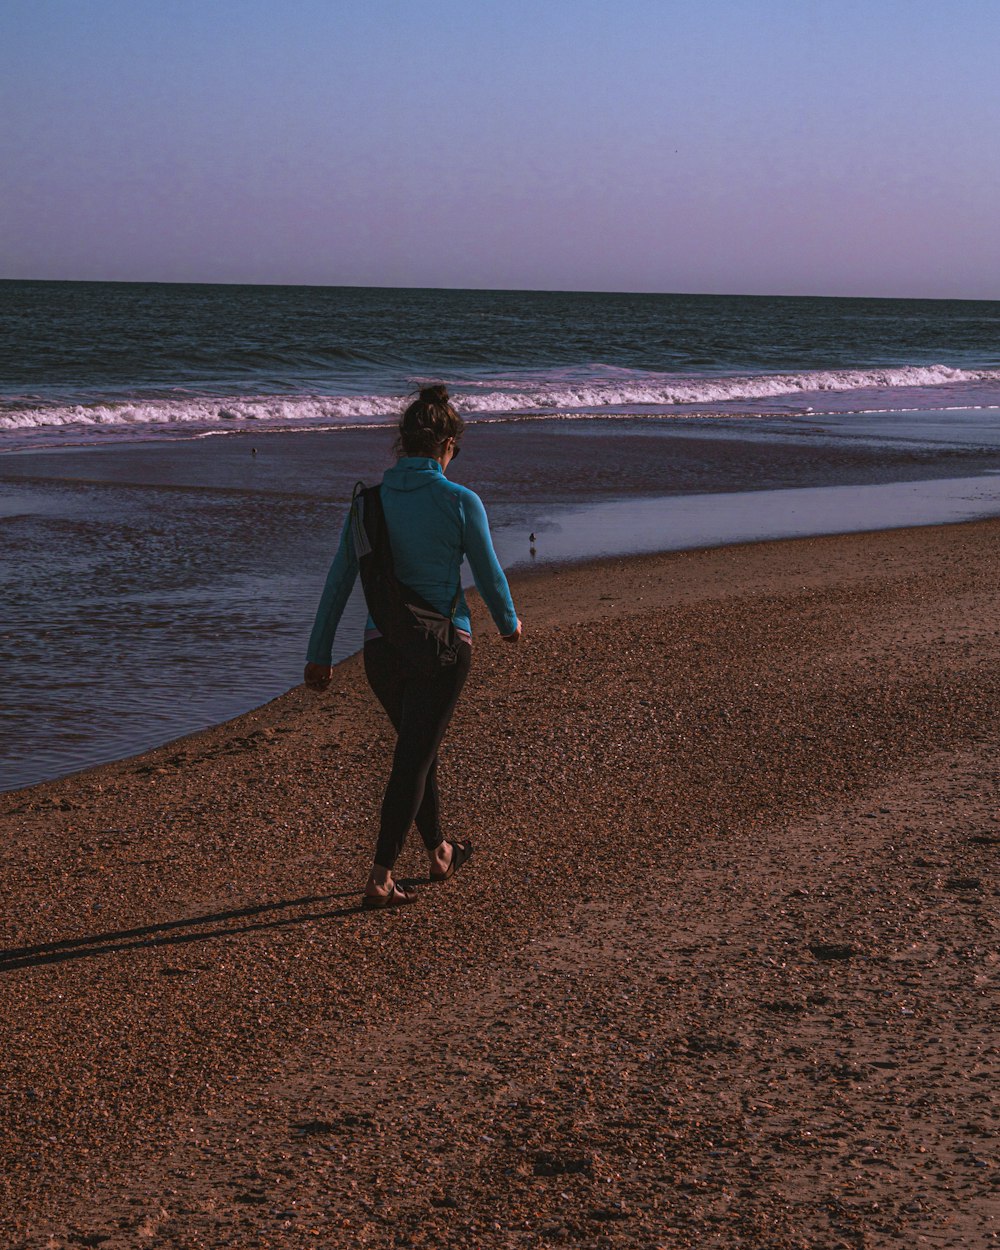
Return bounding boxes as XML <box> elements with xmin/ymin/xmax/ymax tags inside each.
<box><xmin>0</xmin><ymin>283</ymin><xmax>1000</xmax><ymax>449</ymax></box>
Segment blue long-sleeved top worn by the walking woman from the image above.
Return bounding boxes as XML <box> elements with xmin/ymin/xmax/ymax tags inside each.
<box><xmin>306</xmin><ymin>456</ymin><xmax>518</xmax><ymax>664</ymax></box>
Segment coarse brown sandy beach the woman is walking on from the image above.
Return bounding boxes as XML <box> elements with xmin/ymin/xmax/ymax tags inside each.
<box><xmin>0</xmin><ymin>521</ymin><xmax>1000</xmax><ymax>1250</ymax></box>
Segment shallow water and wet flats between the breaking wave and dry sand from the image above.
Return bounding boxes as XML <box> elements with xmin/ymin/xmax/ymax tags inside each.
<box><xmin>0</xmin><ymin>414</ymin><xmax>1000</xmax><ymax>790</ymax></box>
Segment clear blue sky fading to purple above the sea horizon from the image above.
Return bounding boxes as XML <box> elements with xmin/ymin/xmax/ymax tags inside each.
<box><xmin>0</xmin><ymin>0</ymin><xmax>1000</xmax><ymax>299</ymax></box>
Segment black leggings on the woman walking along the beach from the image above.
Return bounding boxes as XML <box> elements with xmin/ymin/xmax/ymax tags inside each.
<box><xmin>365</xmin><ymin>638</ymin><xmax>473</xmax><ymax>869</ymax></box>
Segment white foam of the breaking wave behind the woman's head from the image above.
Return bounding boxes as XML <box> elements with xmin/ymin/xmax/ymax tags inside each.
<box><xmin>0</xmin><ymin>365</ymin><xmax>1000</xmax><ymax>436</ymax></box>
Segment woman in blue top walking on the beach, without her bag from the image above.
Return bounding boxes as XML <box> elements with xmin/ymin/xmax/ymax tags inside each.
<box><xmin>305</xmin><ymin>386</ymin><xmax>521</xmax><ymax>909</ymax></box>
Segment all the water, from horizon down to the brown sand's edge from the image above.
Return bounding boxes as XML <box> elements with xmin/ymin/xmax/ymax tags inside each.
<box><xmin>0</xmin><ymin>283</ymin><xmax>1000</xmax><ymax>789</ymax></box>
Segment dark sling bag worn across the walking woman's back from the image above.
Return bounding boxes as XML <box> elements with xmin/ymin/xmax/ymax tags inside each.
<box><xmin>351</xmin><ymin>481</ymin><xmax>460</xmax><ymax>676</ymax></box>
